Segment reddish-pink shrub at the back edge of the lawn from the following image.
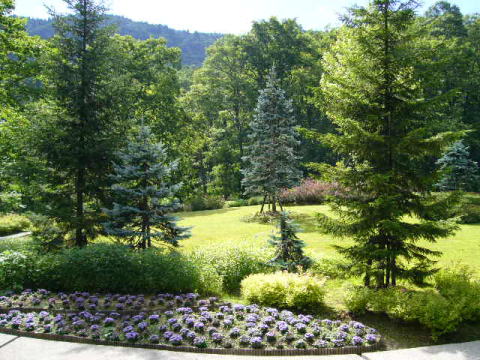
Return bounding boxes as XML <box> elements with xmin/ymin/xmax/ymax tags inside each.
<box><xmin>279</xmin><ymin>179</ymin><xmax>338</xmax><ymax>205</ymax></box>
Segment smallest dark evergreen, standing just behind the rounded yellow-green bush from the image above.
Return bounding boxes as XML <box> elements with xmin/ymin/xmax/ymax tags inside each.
<box><xmin>270</xmin><ymin>212</ymin><xmax>312</xmax><ymax>272</ymax></box>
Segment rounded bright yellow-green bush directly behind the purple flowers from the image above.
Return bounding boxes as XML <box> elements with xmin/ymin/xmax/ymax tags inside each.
<box><xmin>241</xmin><ymin>272</ymin><xmax>325</xmax><ymax>311</ymax></box>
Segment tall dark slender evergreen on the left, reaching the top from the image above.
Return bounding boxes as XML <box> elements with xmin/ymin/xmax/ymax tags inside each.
<box><xmin>41</xmin><ymin>0</ymin><xmax>127</xmax><ymax>246</ymax></box>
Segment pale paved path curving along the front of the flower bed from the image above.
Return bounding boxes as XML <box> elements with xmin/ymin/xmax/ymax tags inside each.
<box><xmin>0</xmin><ymin>334</ymin><xmax>480</xmax><ymax>360</ymax></box>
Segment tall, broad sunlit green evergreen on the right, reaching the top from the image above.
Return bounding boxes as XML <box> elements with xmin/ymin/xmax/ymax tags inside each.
<box><xmin>319</xmin><ymin>0</ymin><xmax>463</xmax><ymax>287</ymax></box>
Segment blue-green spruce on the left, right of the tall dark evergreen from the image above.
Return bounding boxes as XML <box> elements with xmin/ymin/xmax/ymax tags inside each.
<box><xmin>104</xmin><ymin>126</ymin><xmax>189</xmax><ymax>249</ymax></box>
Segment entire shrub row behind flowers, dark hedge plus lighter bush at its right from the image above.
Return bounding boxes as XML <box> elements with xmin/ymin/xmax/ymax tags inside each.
<box><xmin>0</xmin><ymin>243</ymin><xmax>269</xmax><ymax>294</ymax></box>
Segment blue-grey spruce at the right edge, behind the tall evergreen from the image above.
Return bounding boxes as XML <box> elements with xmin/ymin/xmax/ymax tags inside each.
<box><xmin>437</xmin><ymin>141</ymin><xmax>478</xmax><ymax>191</ymax></box>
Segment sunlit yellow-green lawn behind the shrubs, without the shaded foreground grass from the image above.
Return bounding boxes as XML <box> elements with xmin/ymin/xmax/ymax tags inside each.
<box><xmin>179</xmin><ymin>205</ymin><xmax>480</xmax><ymax>274</ymax></box>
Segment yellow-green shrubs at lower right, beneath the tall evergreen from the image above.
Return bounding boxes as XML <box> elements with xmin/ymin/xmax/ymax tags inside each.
<box><xmin>346</xmin><ymin>269</ymin><xmax>480</xmax><ymax>339</ymax></box>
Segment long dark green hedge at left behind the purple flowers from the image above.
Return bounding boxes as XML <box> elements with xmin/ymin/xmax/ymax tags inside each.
<box><xmin>0</xmin><ymin>244</ymin><xmax>218</xmax><ymax>294</ymax></box>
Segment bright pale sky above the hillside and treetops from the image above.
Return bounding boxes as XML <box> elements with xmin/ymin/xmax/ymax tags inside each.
<box><xmin>15</xmin><ymin>0</ymin><xmax>480</xmax><ymax>34</ymax></box>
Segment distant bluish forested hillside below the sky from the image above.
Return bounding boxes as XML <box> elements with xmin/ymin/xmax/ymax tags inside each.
<box><xmin>27</xmin><ymin>15</ymin><xmax>223</xmax><ymax>66</ymax></box>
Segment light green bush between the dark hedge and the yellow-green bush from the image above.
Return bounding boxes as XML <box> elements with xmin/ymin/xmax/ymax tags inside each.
<box><xmin>188</xmin><ymin>245</ymin><xmax>272</xmax><ymax>293</ymax></box>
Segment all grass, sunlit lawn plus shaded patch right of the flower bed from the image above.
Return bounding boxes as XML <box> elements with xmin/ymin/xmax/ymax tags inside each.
<box><xmin>179</xmin><ymin>205</ymin><xmax>480</xmax><ymax>349</ymax></box>
